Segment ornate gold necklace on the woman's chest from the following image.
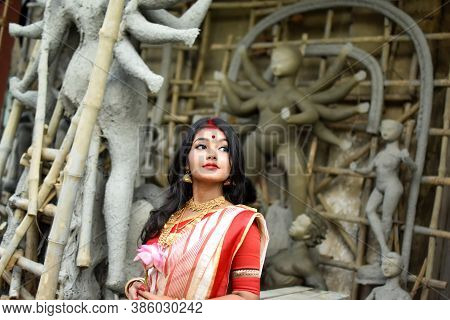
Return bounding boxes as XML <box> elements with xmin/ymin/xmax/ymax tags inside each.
<box><xmin>158</xmin><ymin>196</ymin><xmax>225</xmax><ymax>247</ymax></box>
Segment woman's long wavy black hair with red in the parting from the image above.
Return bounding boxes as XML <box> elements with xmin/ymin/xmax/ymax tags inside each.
<box><xmin>140</xmin><ymin>118</ymin><xmax>248</xmax><ymax>243</ymax></box>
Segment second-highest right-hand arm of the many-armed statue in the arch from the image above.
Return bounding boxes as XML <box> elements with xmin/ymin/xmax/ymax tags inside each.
<box><xmin>307</xmin><ymin>70</ymin><xmax>367</xmax><ymax>104</ymax></box>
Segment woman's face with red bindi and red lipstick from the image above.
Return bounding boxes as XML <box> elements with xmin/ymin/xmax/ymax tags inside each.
<box><xmin>188</xmin><ymin>128</ymin><xmax>231</xmax><ymax>183</ymax></box>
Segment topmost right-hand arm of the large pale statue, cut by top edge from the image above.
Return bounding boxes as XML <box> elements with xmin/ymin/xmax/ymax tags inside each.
<box><xmin>139</xmin><ymin>0</ymin><xmax>212</xmax><ymax>29</ymax></box>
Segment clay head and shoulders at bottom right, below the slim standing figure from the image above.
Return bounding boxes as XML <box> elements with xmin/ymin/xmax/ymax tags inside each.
<box><xmin>366</xmin><ymin>252</ymin><xmax>411</xmax><ymax>300</ymax></box>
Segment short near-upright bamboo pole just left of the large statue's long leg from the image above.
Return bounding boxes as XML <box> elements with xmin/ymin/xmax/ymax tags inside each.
<box><xmin>77</xmin><ymin>125</ymin><xmax>100</xmax><ymax>267</ymax></box>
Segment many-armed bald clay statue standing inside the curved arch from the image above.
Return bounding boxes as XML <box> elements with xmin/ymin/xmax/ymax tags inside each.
<box><xmin>216</xmin><ymin>45</ymin><xmax>369</xmax><ymax>218</ymax></box>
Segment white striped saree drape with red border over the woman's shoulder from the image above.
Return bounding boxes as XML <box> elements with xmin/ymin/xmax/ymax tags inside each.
<box><xmin>149</xmin><ymin>205</ymin><xmax>269</xmax><ymax>299</ymax></box>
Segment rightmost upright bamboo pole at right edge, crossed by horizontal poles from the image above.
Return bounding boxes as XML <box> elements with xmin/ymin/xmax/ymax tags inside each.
<box><xmin>420</xmin><ymin>72</ymin><xmax>450</xmax><ymax>300</ymax></box>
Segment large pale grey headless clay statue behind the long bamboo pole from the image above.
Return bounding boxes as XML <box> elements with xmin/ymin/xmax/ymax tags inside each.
<box><xmin>8</xmin><ymin>0</ymin><xmax>211</xmax><ymax>292</ymax></box>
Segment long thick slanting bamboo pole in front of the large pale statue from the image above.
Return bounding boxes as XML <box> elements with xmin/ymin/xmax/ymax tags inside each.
<box><xmin>36</xmin><ymin>0</ymin><xmax>124</xmax><ymax>299</ymax></box>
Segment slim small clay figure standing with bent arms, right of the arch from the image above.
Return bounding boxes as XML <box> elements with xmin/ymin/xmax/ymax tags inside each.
<box><xmin>350</xmin><ymin>120</ymin><xmax>416</xmax><ymax>284</ymax></box>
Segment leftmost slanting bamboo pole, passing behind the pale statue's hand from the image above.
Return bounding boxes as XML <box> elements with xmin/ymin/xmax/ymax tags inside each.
<box><xmin>0</xmin><ymin>41</ymin><xmax>40</xmax><ymax>177</ymax></box>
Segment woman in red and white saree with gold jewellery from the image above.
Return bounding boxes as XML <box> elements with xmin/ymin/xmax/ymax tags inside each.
<box><xmin>125</xmin><ymin>118</ymin><xmax>268</xmax><ymax>300</ymax></box>
